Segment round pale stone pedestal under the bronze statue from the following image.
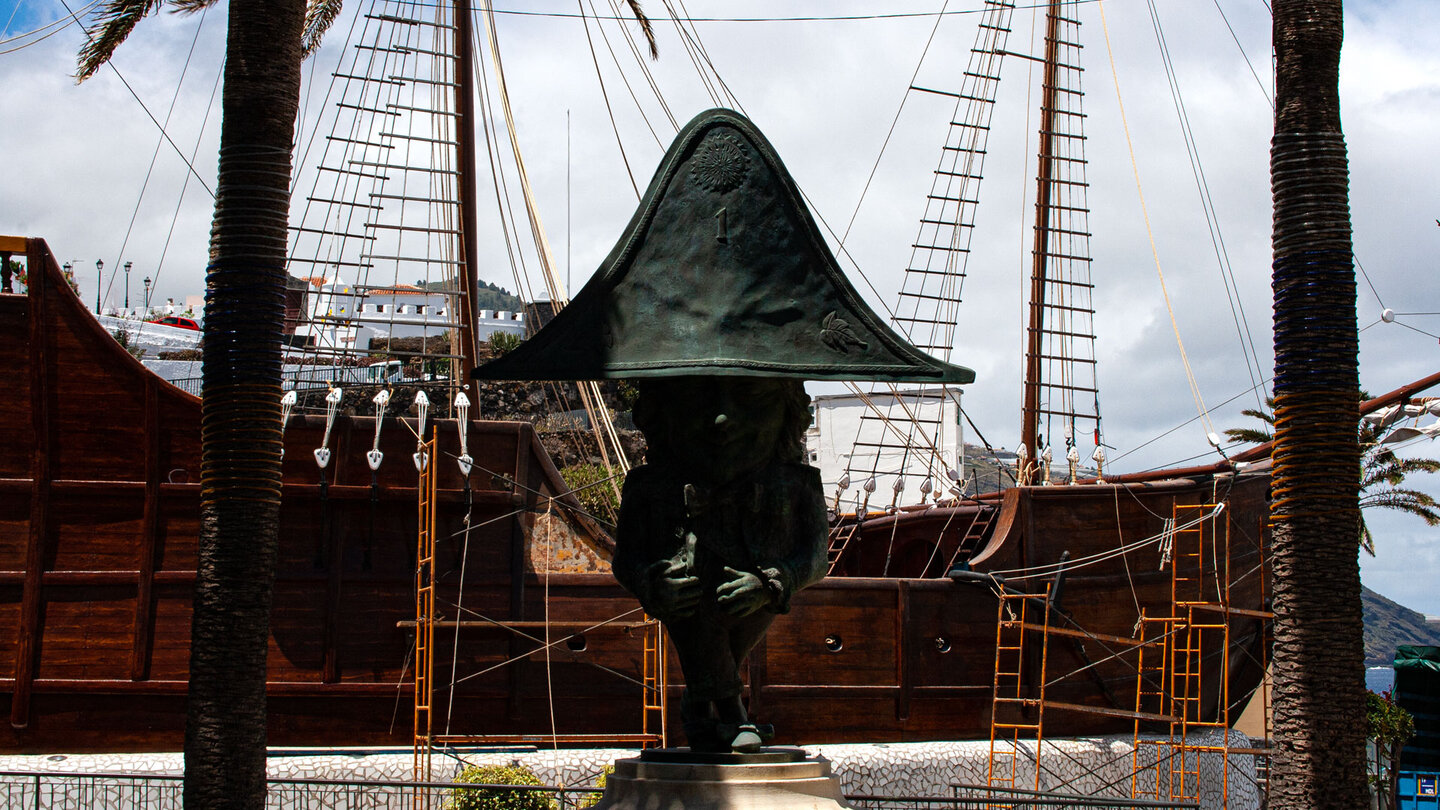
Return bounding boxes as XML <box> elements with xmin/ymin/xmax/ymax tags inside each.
<box><xmin>595</xmin><ymin>748</ymin><xmax>850</xmax><ymax>810</ymax></box>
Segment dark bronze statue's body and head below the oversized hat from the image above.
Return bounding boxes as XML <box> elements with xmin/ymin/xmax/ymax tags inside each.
<box><xmin>612</xmin><ymin>376</ymin><xmax>827</xmax><ymax>751</ymax></box>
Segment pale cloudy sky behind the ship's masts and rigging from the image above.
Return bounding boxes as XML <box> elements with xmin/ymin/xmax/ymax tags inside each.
<box><xmin>8</xmin><ymin>0</ymin><xmax>1440</xmax><ymax>614</ymax></box>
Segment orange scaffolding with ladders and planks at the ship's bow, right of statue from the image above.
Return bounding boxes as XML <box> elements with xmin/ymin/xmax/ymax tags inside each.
<box><xmin>986</xmin><ymin>503</ymin><xmax>1273</xmax><ymax>807</ymax></box>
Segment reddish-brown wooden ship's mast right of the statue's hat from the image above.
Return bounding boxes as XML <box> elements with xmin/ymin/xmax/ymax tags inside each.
<box><xmin>1020</xmin><ymin>0</ymin><xmax>1060</xmax><ymax>458</ymax></box>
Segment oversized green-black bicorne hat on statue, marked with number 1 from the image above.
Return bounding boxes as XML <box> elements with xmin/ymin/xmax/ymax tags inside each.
<box><xmin>475</xmin><ymin>110</ymin><xmax>975</xmax><ymax>383</ymax></box>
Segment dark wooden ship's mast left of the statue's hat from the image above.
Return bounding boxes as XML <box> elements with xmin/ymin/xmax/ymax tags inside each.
<box><xmin>455</xmin><ymin>0</ymin><xmax>480</xmax><ymax>388</ymax></box>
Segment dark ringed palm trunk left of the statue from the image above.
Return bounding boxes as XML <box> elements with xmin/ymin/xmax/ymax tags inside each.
<box><xmin>184</xmin><ymin>0</ymin><xmax>304</xmax><ymax>809</ymax></box>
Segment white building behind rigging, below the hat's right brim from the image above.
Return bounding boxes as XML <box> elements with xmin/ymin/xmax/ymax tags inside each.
<box><xmin>805</xmin><ymin>386</ymin><xmax>965</xmax><ymax>509</ymax></box>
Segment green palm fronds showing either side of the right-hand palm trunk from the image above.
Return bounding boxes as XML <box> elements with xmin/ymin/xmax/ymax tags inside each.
<box><xmin>1225</xmin><ymin>391</ymin><xmax>1440</xmax><ymax>556</ymax></box>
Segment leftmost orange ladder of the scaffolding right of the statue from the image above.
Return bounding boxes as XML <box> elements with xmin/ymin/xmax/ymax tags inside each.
<box><xmin>985</xmin><ymin>585</ymin><xmax>1050</xmax><ymax>790</ymax></box>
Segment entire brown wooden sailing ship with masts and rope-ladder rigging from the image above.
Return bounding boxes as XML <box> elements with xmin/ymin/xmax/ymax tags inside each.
<box><xmin>0</xmin><ymin>1</ymin><xmax>1307</xmax><ymax>751</ymax></box>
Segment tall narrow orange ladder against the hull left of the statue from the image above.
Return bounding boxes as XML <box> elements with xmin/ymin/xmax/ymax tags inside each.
<box><xmin>413</xmin><ymin>428</ymin><xmax>438</xmax><ymax>795</ymax></box>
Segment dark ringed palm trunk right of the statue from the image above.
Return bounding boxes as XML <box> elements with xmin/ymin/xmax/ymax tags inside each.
<box><xmin>1270</xmin><ymin>0</ymin><xmax>1369</xmax><ymax>810</ymax></box>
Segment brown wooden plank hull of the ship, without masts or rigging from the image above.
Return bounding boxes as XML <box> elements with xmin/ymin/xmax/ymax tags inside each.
<box><xmin>0</xmin><ymin>239</ymin><xmax>1267</xmax><ymax>752</ymax></box>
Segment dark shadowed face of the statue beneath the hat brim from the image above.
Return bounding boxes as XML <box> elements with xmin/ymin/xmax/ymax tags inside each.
<box><xmin>648</xmin><ymin>376</ymin><xmax>785</xmax><ymax>484</ymax></box>
